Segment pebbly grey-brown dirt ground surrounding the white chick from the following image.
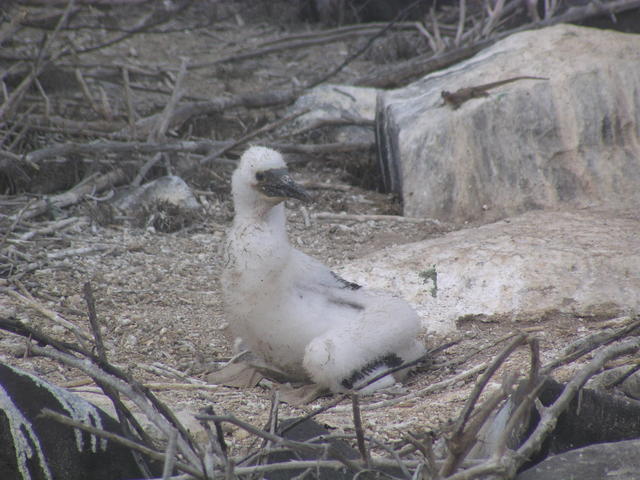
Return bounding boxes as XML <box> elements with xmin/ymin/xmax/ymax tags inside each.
<box><xmin>0</xmin><ymin>2</ymin><xmax>632</xmax><ymax>462</ymax></box>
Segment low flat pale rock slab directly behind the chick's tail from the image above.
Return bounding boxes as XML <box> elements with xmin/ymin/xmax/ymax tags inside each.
<box><xmin>339</xmin><ymin>210</ymin><xmax>640</xmax><ymax>333</ymax></box>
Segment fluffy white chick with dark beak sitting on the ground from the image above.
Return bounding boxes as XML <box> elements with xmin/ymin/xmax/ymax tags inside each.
<box><xmin>222</xmin><ymin>147</ymin><xmax>425</xmax><ymax>392</ymax></box>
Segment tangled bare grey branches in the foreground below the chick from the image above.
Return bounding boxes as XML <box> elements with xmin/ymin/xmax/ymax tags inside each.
<box><xmin>0</xmin><ymin>292</ymin><xmax>640</xmax><ymax>480</ymax></box>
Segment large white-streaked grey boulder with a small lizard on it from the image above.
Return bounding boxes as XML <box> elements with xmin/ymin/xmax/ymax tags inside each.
<box><xmin>376</xmin><ymin>25</ymin><xmax>640</xmax><ymax>224</ymax></box>
